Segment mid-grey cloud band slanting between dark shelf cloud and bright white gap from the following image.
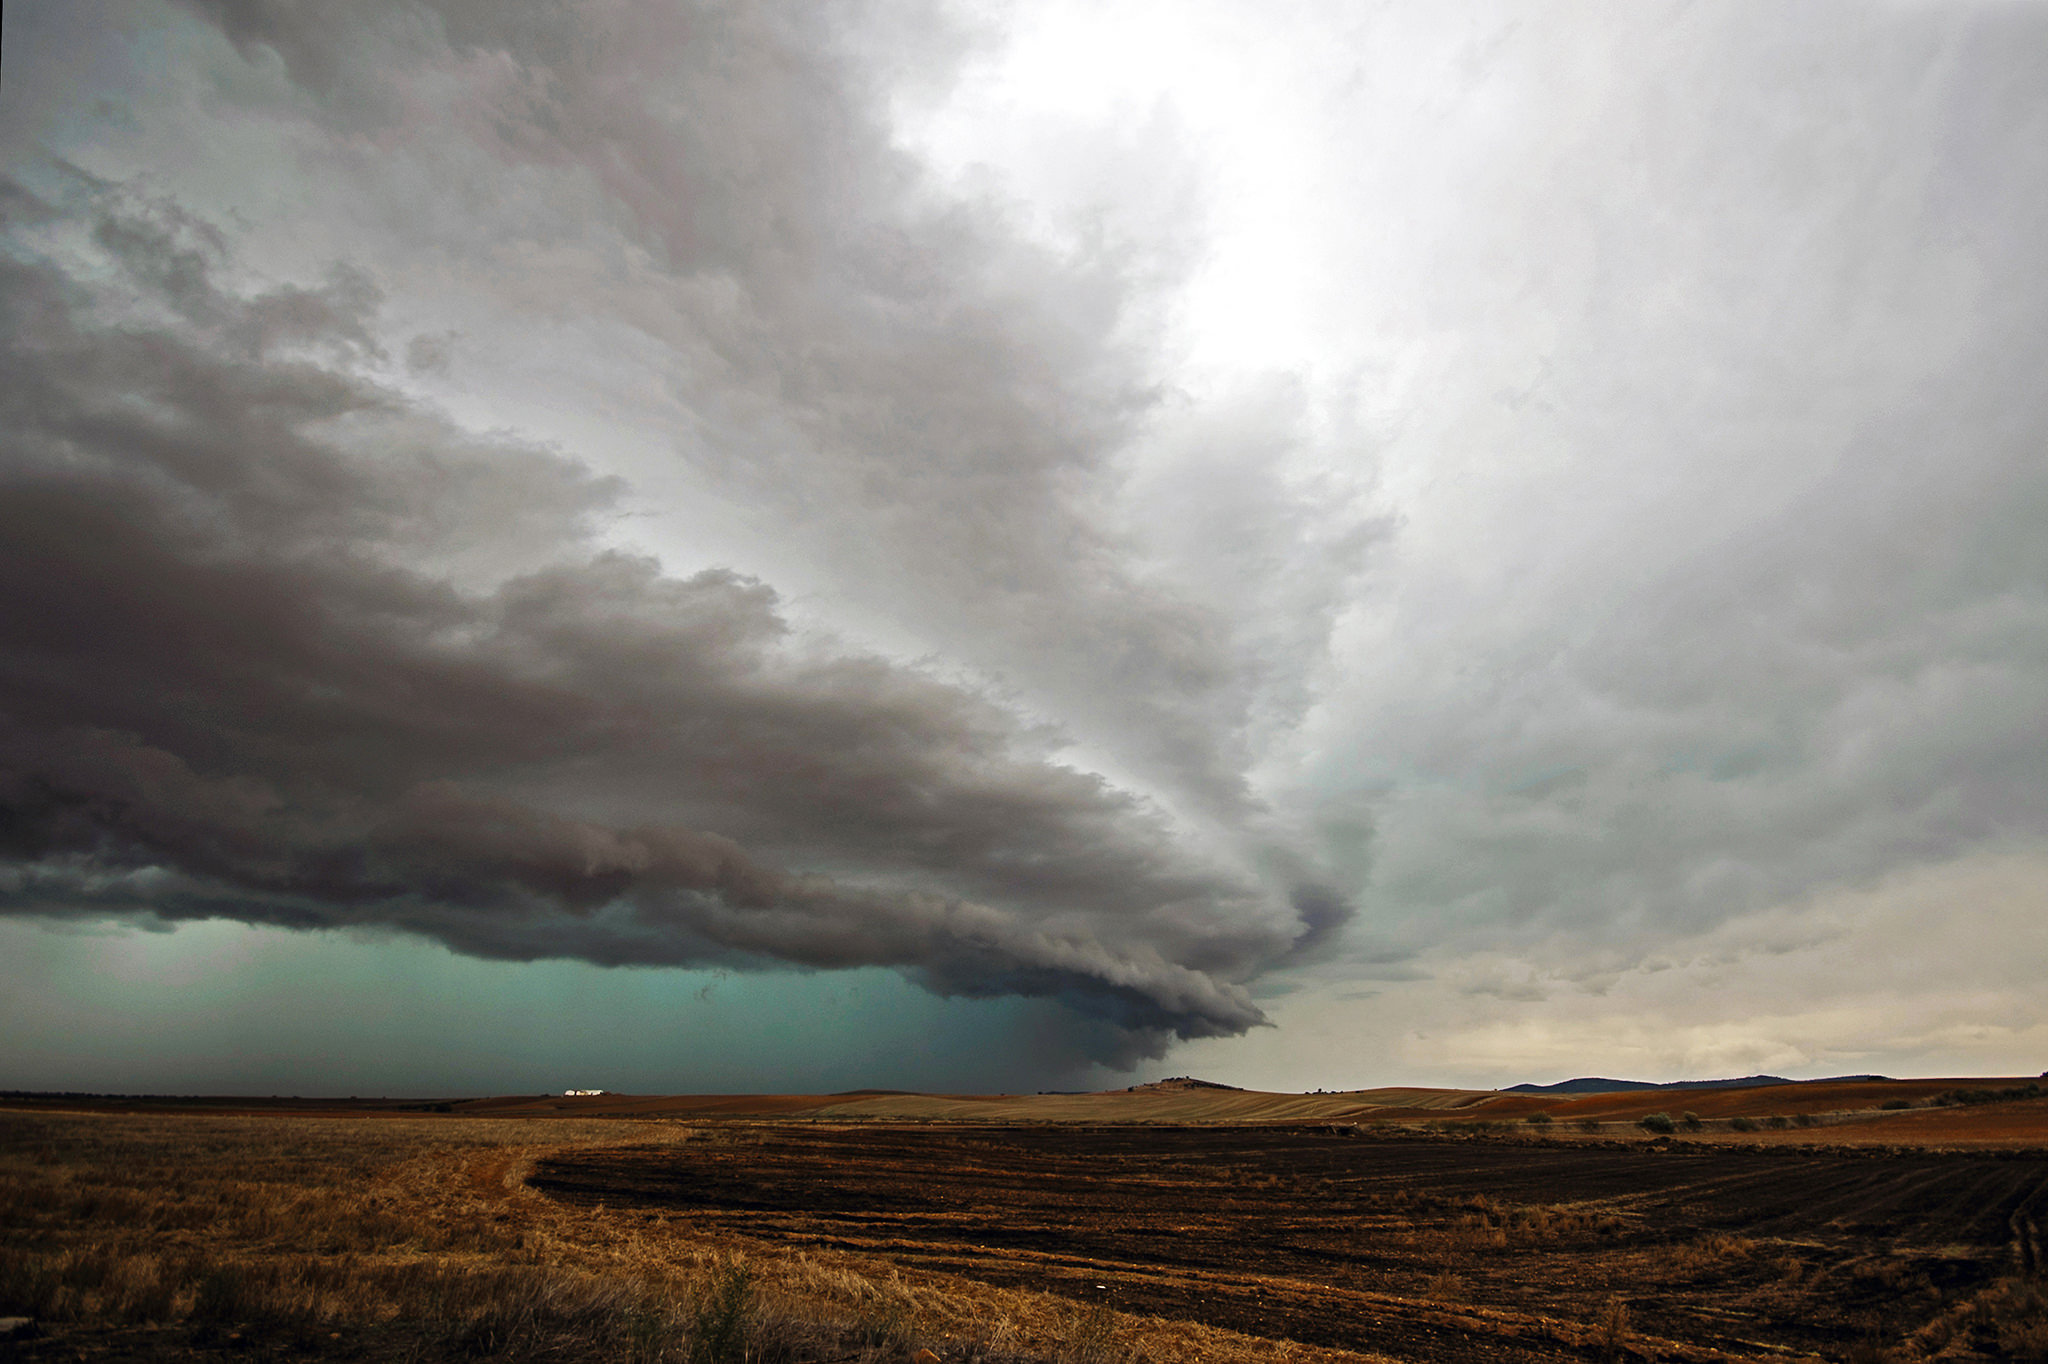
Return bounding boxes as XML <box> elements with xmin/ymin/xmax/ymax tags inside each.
<box><xmin>167</xmin><ymin>0</ymin><xmax>1327</xmax><ymax>827</ymax></box>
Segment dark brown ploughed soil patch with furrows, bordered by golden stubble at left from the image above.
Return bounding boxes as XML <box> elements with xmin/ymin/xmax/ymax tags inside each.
<box><xmin>532</xmin><ymin>1124</ymin><xmax>2048</xmax><ymax>1360</ymax></box>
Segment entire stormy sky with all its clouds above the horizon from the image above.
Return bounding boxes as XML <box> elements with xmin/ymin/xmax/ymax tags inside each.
<box><xmin>0</xmin><ymin>0</ymin><xmax>2048</xmax><ymax>1096</ymax></box>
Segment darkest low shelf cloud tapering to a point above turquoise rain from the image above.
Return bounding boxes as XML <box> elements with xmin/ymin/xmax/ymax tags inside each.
<box><xmin>0</xmin><ymin>176</ymin><xmax>1277</xmax><ymax>1044</ymax></box>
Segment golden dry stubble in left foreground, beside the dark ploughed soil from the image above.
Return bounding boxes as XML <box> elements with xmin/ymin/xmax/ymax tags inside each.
<box><xmin>0</xmin><ymin>1108</ymin><xmax>1370</xmax><ymax>1364</ymax></box>
